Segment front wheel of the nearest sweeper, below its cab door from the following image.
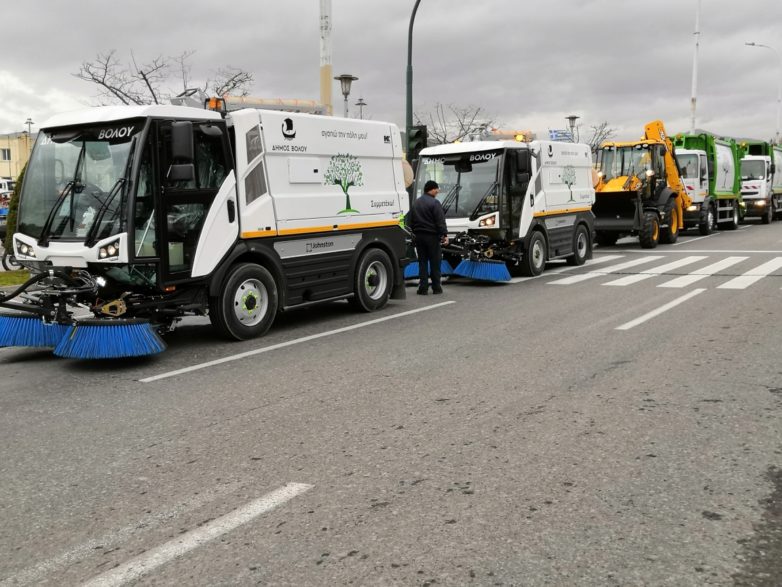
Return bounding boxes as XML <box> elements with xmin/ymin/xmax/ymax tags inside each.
<box><xmin>209</xmin><ymin>263</ymin><xmax>279</xmax><ymax>340</ymax></box>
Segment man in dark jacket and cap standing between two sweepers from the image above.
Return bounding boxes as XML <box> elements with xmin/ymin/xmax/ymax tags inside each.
<box><xmin>408</xmin><ymin>181</ymin><xmax>448</xmax><ymax>296</ymax></box>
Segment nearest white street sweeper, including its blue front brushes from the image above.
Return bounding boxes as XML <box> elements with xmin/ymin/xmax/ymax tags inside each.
<box><xmin>0</xmin><ymin>93</ymin><xmax>408</xmax><ymax>358</ymax></box>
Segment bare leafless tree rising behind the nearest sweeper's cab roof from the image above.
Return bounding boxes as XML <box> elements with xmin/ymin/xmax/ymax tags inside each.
<box><xmin>73</xmin><ymin>49</ymin><xmax>254</xmax><ymax>104</ymax></box>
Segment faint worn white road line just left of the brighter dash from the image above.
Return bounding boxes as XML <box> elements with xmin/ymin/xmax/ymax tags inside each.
<box><xmin>0</xmin><ymin>482</ymin><xmax>240</xmax><ymax>587</ymax></box>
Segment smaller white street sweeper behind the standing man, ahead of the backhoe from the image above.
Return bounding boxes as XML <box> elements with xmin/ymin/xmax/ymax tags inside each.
<box><xmin>415</xmin><ymin>140</ymin><xmax>595</xmax><ymax>281</ymax></box>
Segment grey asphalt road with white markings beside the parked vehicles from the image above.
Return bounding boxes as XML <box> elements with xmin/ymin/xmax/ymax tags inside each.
<box><xmin>0</xmin><ymin>223</ymin><xmax>782</xmax><ymax>587</ymax></box>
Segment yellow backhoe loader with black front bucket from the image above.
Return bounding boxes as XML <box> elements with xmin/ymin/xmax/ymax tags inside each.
<box><xmin>592</xmin><ymin>120</ymin><xmax>691</xmax><ymax>249</ymax></box>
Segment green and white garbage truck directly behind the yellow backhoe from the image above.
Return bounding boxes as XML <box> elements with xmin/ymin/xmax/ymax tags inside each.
<box><xmin>673</xmin><ymin>130</ymin><xmax>744</xmax><ymax>235</ymax></box>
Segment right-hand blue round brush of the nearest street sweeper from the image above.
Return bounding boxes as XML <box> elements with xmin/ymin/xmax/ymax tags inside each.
<box><xmin>54</xmin><ymin>319</ymin><xmax>166</xmax><ymax>359</ymax></box>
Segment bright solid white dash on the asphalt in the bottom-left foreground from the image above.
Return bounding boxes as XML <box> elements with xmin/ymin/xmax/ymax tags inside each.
<box><xmin>83</xmin><ymin>483</ymin><xmax>312</xmax><ymax>587</ymax></box>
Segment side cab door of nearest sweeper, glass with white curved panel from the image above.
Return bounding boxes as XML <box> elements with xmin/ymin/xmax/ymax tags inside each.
<box><xmin>157</xmin><ymin>121</ymin><xmax>239</xmax><ymax>284</ymax></box>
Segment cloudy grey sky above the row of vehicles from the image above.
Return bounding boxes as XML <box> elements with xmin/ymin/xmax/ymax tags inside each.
<box><xmin>0</xmin><ymin>0</ymin><xmax>782</xmax><ymax>139</ymax></box>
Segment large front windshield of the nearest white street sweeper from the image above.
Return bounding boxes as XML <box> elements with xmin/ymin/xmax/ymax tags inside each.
<box><xmin>18</xmin><ymin>121</ymin><xmax>143</xmax><ymax>240</ymax></box>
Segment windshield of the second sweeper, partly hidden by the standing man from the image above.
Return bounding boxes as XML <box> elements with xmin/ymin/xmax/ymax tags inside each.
<box><xmin>415</xmin><ymin>149</ymin><xmax>502</xmax><ymax>218</ymax></box>
